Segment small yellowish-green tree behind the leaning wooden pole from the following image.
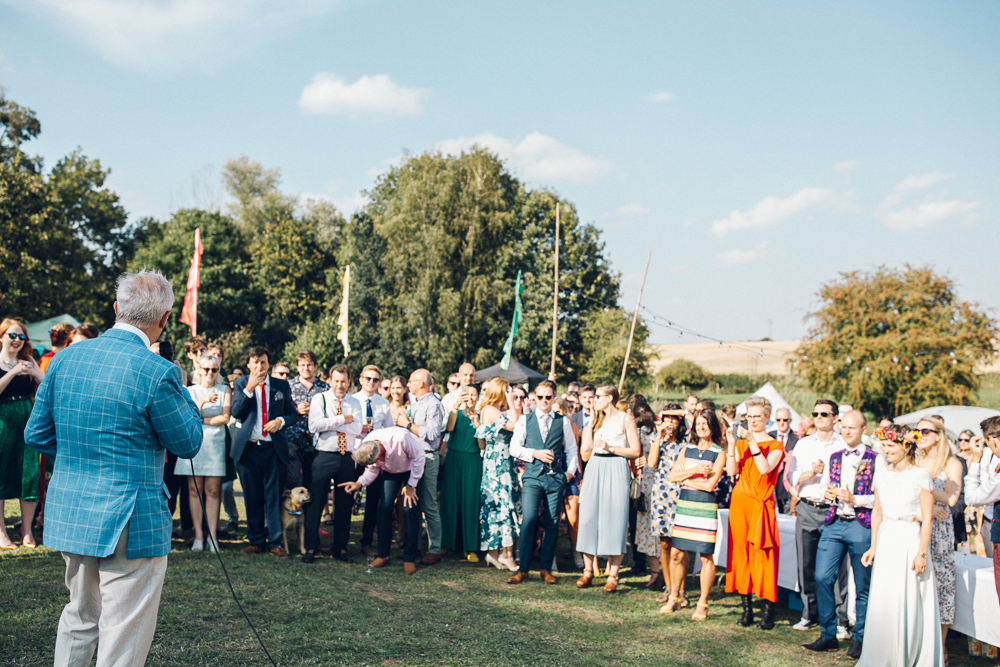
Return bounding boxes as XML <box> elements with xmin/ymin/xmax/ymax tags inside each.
<box><xmin>580</xmin><ymin>308</ymin><xmax>649</xmax><ymax>395</ymax></box>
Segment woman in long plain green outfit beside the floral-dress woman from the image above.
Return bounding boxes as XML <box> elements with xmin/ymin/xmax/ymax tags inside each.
<box><xmin>441</xmin><ymin>385</ymin><xmax>483</xmax><ymax>563</ymax></box>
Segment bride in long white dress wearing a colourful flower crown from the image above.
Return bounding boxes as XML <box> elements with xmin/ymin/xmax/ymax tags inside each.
<box><xmin>856</xmin><ymin>424</ymin><xmax>944</xmax><ymax>667</ymax></box>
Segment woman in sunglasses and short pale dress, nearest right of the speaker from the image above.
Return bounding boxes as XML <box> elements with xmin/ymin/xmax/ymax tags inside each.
<box><xmin>174</xmin><ymin>352</ymin><xmax>232</xmax><ymax>551</ymax></box>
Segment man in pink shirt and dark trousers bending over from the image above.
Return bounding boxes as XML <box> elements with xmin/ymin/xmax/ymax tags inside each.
<box><xmin>340</xmin><ymin>426</ymin><xmax>426</xmax><ymax>574</ymax></box>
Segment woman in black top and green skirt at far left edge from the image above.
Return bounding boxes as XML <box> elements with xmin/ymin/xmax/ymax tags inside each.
<box><xmin>0</xmin><ymin>318</ymin><xmax>42</xmax><ymax>549</ymax></box>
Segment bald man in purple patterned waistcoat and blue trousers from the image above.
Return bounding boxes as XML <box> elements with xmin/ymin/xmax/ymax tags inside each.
<box><xmin>802</xmin><ymin>410</ymin><xmax>886</xmax><ymax>660</ymax></box>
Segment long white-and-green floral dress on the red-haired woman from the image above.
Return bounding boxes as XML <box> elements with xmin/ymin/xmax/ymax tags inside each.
<box><xmin>476</xmin><ymin>415</ymin><xmax>521</xmax><ymax>550</ymax></box>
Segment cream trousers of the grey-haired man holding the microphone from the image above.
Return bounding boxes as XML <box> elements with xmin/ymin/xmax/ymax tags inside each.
<box><xmin>54</xmin><ymin>526</ymin><xmax>167</xmax><ymax>667</ymax></box>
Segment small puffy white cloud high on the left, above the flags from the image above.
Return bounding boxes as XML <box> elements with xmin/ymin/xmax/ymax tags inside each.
<box><xmin>299</xmin><ymin>72</ymin><xmax>426</xmax><ymax>116</ymax></box>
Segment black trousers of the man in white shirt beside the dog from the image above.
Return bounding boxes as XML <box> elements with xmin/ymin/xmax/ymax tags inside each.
<box><xmin>305</xmin><ymin>452</ymin><xmax>361</xmax><ymax>555</ymax></box>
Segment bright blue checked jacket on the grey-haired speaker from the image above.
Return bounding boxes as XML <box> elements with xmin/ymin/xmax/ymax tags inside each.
<box><xmin>24</xmin><ymin>329</ymin><xmax>202</xmax><ymax>558</ymax></box>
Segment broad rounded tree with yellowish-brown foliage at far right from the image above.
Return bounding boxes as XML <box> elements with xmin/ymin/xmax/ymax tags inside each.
<box><xmin>796</xmin><ymin>265</ymin><xmax>998</xmax><ymax>415</ymax></box>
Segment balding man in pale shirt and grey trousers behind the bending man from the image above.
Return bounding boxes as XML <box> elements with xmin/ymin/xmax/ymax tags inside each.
<box><xmin>395</xmin><ymin>368</ymin><xmax>446</xmax><ymax>565</ymax></box>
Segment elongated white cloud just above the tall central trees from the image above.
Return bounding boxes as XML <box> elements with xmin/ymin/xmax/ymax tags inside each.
<box><xmin>435</xmin><ymin>132</ymin><xmax>614</xmax><ymax>183</ymax></box>
